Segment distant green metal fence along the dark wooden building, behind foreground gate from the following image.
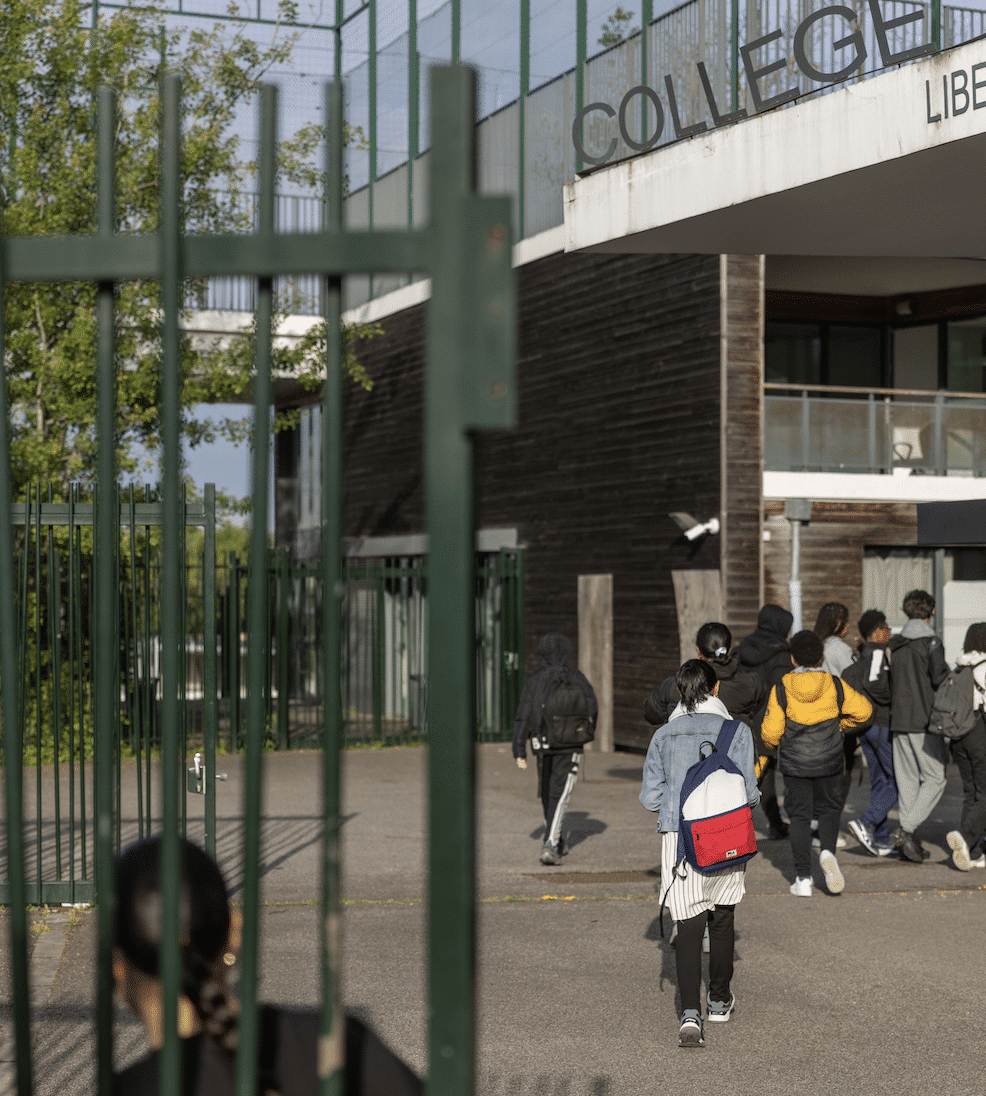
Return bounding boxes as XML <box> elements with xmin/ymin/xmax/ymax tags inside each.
<box><xmin>218</xmin><ymin>549</ymin><xmax>525</xmax><ymax>751</ymax></box>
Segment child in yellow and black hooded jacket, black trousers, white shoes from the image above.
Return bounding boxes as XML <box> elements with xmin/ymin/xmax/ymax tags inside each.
<box><xmin>760</xmin><ymin>631</ymin><xmax>873</xmax><ymax>898</ymax></box>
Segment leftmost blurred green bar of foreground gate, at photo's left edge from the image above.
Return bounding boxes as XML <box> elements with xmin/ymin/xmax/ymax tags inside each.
<box><xmin>0</xmin><ymin>128</ymin><xmax>33</xmax><ymax>1096</ymax></box>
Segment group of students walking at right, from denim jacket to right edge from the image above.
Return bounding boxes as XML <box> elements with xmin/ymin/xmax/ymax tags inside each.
<box><xmin>640</xmin><ymin>590</ymin><xmax>986</xmax><ymax>1047</ymax></box>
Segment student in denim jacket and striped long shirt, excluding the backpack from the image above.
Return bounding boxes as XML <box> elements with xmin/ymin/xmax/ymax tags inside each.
<box><xmin>640</xmin><ymin>659</ymin><xmax>760</xmax><ymax>1047</ymax></box>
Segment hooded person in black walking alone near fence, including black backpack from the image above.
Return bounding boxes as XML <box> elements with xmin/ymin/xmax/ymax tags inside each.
<box><xmin>514</xmin><ymin>631</ymin><xmax>599</xmax><ymax>865</ymax></box>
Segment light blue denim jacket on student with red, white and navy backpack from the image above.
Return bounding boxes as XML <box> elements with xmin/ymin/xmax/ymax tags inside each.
<box><xmin>640</xmin><ymin>711</ymin><xmax>760</xmax><ymax>833</ymax></box>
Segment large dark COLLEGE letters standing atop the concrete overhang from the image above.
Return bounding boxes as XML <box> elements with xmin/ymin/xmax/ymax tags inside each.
<box><xmin>572</xmin><ymin>0</ymin><xmax>935</xmax><ymax>164</ymax></box>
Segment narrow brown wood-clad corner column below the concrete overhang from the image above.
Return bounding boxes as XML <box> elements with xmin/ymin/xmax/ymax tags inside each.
<box><xmin>720</xmin><ymin>255</ymin><xmax>764</xmax><ymax>639</ymax></box>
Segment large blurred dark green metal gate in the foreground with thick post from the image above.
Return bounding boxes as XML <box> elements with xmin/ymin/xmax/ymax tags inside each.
<box><xmin>0</xmin><ymin>68</ymin><xmax>515</xmax><ymax>1096</ymax></box>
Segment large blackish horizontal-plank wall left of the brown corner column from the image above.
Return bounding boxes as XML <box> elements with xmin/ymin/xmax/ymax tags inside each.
<box><xmin>346</xmin><ymin>254</ymin><xmax>721</xmax><ymax>745</ymax></box>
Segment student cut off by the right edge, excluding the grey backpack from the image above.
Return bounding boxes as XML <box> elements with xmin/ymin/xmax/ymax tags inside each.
<box><xmin>945</xmin><ymin>624</ymin><xmax>986</xmax><ymax>871</ymax></box>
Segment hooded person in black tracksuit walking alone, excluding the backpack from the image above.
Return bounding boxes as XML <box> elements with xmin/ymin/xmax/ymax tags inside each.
<box><xmin>514</xmin><ymin>631</ymin><xmax>599</xmax><ymax>864</ymax></box>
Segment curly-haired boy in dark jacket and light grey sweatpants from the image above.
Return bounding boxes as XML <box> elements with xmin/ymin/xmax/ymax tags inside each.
<box><xmin>890</xmin><ymin>590</ymin><xmax>949</xmax><ymax>864</ymax></box>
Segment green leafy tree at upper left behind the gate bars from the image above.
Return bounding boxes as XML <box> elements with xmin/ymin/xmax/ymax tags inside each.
<box><xmin>0</xmin><ymin>0</ymin><xmax>376</xmax><ymax>498</ymax></box>
